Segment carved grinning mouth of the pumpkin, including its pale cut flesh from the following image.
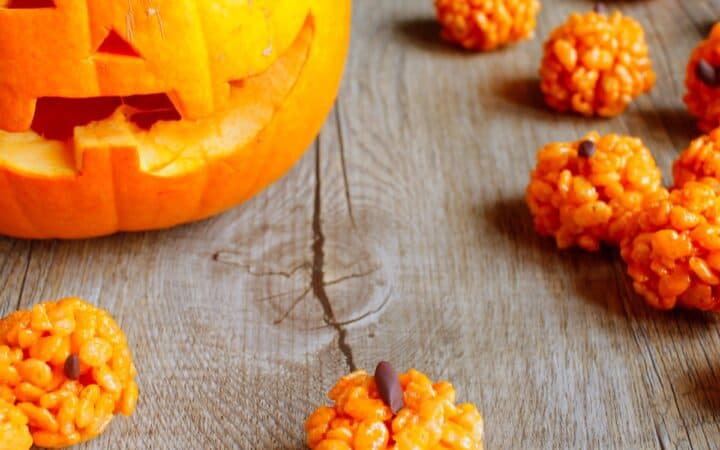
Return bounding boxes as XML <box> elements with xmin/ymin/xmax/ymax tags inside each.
<box><xmin>0</xmin><ymin>14</ymin><xmax>315</xmax><ymax>177</ymax></box>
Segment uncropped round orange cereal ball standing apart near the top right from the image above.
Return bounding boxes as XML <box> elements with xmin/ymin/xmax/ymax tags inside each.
<box><xmin>540</xmin><ymin>7</ymin><xmax>655</xmax><ymax>117</ymax></box>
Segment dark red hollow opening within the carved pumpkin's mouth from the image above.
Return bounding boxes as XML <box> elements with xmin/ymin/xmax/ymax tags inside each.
<box><xmin>31</xmin><ymin>94</ymin><xmax>181</xmax><ymax>141</ymax></box>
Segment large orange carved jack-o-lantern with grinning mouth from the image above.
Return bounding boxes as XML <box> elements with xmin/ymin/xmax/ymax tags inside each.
<box><xmin>0</xmin><ymin>0</ymin><xmax>350</xmax><ymax>238</ymax></box>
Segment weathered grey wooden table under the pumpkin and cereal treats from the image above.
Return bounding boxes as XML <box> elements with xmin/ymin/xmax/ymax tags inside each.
<box><xmin>0</xmin><ymin>0</ymin><xmax>720</xmax><ymax>449</ymax></box>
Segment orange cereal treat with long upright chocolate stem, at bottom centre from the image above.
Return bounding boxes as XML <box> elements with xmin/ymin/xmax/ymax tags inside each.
<box><xmin>305</xmin><ymin>362</ymin><xmax>483</xmax><ymax>450</ymax></box>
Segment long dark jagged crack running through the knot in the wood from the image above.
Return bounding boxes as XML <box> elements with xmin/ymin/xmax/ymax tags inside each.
<box><xmin>310</xmin><ymin>142</ymin><xmax>357</xmax><ymax>372</ymax></box>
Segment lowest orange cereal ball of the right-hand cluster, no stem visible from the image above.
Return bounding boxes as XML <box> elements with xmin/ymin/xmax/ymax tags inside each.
<box><xmin>621</xmin><ymin>178</ymin><xmax>720</xmax><ymax>311</ymax></box>
